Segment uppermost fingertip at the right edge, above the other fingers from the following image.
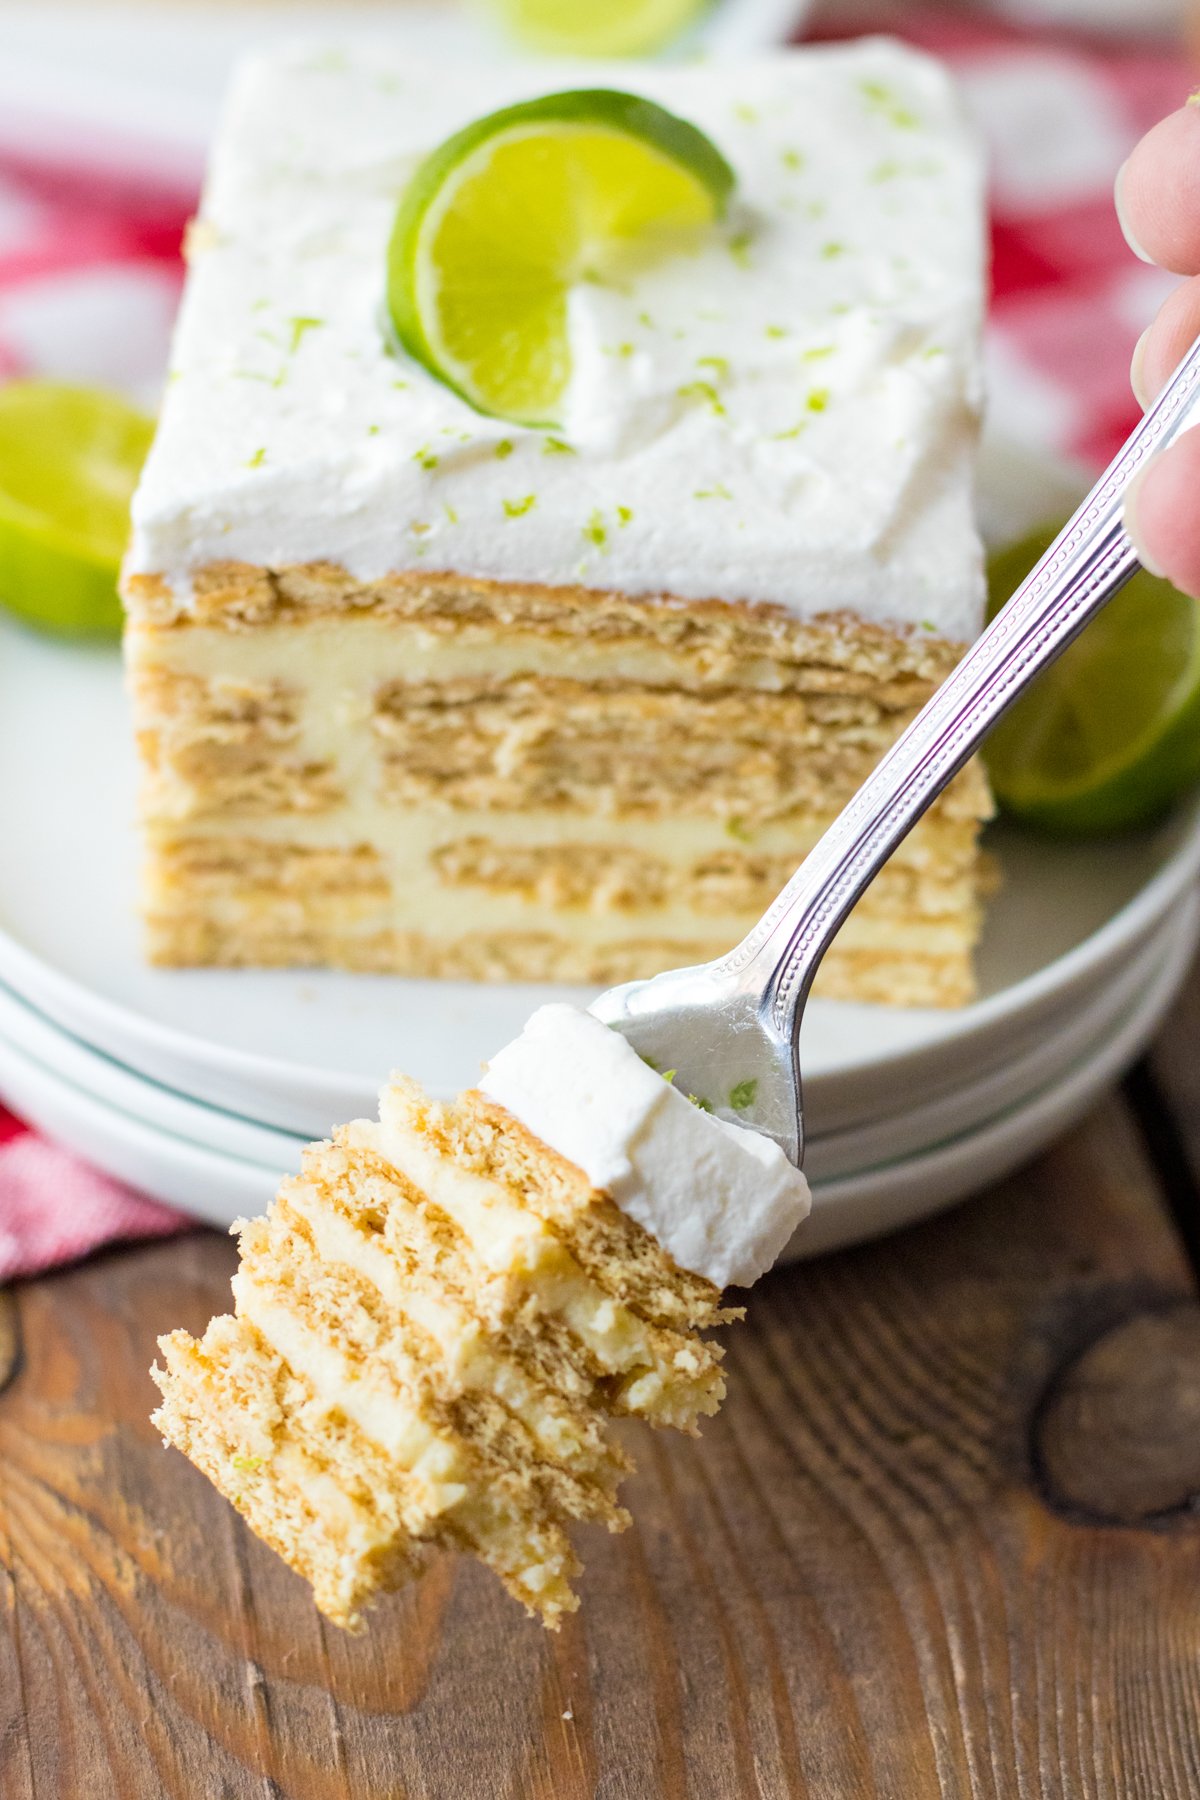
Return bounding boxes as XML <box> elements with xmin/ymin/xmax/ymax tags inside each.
<box><xmin>1117</xmin><ymin>106</ymin><xmax>1200</xmax><ymax>275</ymax></box>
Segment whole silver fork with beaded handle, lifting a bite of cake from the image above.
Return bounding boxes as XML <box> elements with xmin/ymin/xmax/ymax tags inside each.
<box><xmin>592</xmin><ymin>340</ymin><xmax>1200</xmax><ymax>1165</ymax></box>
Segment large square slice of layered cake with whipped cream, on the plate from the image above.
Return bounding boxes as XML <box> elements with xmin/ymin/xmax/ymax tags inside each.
<box><xmin>122</xmin><ymin>40</ymin><xmax>990</xmax><ymax>1004</ymax></box>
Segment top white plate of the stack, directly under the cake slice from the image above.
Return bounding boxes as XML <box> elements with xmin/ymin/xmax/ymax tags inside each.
<box><xmin>0</xmin><ymin>597</ymin><xmax>1200</xmax><ymax>1136</ymax></box>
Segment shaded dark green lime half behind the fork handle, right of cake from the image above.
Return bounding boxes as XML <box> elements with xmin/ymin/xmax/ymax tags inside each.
<box><xmin>984</xmin><ymin>526</ymin><xmax>1200</xmax><ymax>837</ymax></box>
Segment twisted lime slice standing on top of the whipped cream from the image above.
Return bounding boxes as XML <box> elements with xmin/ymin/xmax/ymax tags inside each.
<box><xmin>387</xmin><ymin>88</ymin><xmax>734</xmax><ymax>425</ymax></box>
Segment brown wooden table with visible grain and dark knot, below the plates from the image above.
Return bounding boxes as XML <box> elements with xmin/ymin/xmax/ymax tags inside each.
<box><xmin>0</xmin><ymin>977</ymin><xmax>1200</xmax><ymax>1800</ymax></box>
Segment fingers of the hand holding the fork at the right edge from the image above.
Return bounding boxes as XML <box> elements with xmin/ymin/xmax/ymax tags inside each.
<box><xmin>1117</xmin><ymin>95</ymin><xmax>1200</xmax><ymax>598</ymax></box>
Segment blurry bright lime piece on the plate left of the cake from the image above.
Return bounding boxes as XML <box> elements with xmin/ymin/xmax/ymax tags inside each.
<box><xmin>0</xmin><ymin>382</ymin><xmax>155</xmax><ymax>637</ymax></box>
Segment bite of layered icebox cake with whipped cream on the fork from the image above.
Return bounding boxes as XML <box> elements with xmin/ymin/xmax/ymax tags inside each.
<box><xmin>153</xmin><ymin>1006</ymin><xmax>810</xmax><ymax>1627</ymax></box>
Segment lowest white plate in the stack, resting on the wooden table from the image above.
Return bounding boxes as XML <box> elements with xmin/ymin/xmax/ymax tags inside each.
<box><xmin>0</xmin><ymin>882</ymin><xmax>1191</xmax><ymax>1258</ymax></box>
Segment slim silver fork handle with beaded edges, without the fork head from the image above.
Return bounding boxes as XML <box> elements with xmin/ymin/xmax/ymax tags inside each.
<box><xmin>716</xmin><ymin>340</ymin><xmax>1200</xmax><ymax>1046</ymax></box>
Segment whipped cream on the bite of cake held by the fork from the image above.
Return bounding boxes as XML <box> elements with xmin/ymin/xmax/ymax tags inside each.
<box><xmin>479</xmin><ymin>1003</ymin><xmax>811</xmax><ymax>1287</ymax></box>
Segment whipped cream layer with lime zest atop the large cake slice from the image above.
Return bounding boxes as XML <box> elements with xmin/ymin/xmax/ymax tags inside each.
<box><xmin>130</xmin><ymin>40</ymin><xmax>984</xmax><ymax>639</ymax></box>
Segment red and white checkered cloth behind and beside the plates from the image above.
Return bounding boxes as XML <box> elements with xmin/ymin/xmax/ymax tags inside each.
<box><xmin>0</xmin><ymin>7</ymin><xmax>1196</xmax><ymax>1280</ymax></box>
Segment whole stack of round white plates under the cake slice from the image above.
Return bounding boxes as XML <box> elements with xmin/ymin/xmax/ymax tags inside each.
<box><xmin>0</xmin><ymin>439</ymin><xmax>1200</xmax><ymax>1253</ymax></box>
